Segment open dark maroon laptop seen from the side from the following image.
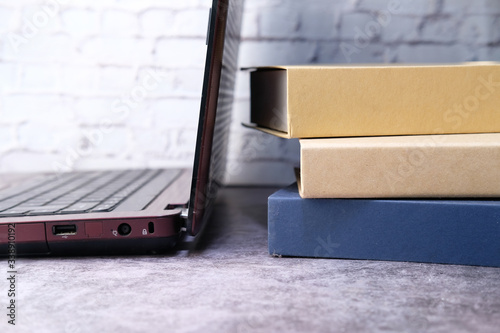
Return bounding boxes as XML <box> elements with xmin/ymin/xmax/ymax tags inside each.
<box><xmin>0</xmin><ymin>0</ymin><xmax>243</xmax><ymax>256</ymax></box>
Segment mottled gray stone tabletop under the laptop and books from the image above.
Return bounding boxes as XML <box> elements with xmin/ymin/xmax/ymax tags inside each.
<box><xmin>0</xmin><ymin>188</ymin><xmax>500</xmax><ymax>333</ymax></box>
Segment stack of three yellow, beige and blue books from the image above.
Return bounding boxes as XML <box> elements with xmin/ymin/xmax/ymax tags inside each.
<box><xmin>251</xmin><ymin>62</ymin><xmax>500</xmax><ymax>266</ymax></box>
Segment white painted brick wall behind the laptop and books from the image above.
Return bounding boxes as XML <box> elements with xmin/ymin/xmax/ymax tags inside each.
<box><xmin>0</xmin><ymin>0</ymin><xmax>500</xmax><ymax>184</ymax></box>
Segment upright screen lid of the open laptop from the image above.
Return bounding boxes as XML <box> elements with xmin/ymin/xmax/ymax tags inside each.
<box><xmin>187</xmin><ymin>0</ymin><xmax>243</xmax><ymax>235</ymax></box>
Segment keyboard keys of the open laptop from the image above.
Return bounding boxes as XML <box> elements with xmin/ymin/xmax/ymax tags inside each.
<box><xmin>0</xmin><ymin>170</ymin><xmax>166</xmax><ymax>217</ymax></box>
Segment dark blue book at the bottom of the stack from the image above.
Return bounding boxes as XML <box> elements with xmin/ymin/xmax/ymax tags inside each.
<box><xmin>268</xmin><ymin>184</ymin><xmax>500</xmax><ymax>267</ymax></box>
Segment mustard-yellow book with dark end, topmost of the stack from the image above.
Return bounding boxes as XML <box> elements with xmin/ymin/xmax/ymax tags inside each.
<box><xmin>251</xmin><ymin>62</ymin><xmax>500</xmax><ymax>138</ymax></box>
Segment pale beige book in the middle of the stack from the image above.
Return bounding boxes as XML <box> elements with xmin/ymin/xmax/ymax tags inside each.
<box><xmin>299</xmin><ymin>133</ymin><xmax>500</xmax><ymax>198</ymax></box>
